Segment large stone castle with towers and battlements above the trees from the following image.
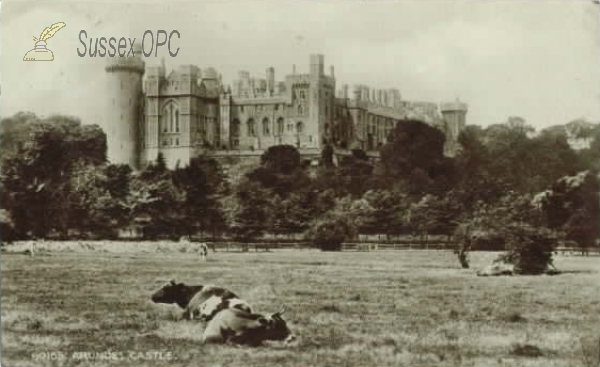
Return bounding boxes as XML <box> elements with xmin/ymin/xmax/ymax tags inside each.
<box><xmin>105</xmin><ymin>47</ymin><xmax>467</xmax><ymax>168</ymax></box>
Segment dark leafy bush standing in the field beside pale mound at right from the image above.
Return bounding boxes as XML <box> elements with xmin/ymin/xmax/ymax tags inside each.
<box><xmin>494</xmin><ymin>223</ymin><xmax>555</xmax><ymax>275</ymax></box>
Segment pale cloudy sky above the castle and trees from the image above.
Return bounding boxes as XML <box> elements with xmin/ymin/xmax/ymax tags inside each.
<box><xmin>0</xmin><ymin>0</ymin><xmax>600</xmax><ymax>130</ymax></box>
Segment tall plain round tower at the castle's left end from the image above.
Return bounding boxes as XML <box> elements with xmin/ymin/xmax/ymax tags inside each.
<box><xmin>104</xmin><ymin>46</ymin><xmax>145</xmax><ymax>169</ymax></box>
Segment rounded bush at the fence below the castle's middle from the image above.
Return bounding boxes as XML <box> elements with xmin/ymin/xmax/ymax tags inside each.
<box><xmin>307</xmin><ymin>216</ymin><xmax>354</xmax><ymax>251</ymax></box>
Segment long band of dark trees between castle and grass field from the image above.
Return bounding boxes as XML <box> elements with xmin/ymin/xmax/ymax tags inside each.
<box><xmin>0</xmin><ymin>113</ymin><xmax>600</xmax><ymax>262</ymax></box>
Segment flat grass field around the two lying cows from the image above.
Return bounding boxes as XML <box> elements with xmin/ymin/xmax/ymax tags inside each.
<box><xmin>1</xmin><ymin>244</ymin><xmax>600</xmax><ymax>367</ymax></box>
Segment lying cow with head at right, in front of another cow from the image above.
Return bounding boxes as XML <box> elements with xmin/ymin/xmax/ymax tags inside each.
<box><xmin>201</xmin><ymin>308</ymin><xmax>295</xmax><ymax>346</ymax></box>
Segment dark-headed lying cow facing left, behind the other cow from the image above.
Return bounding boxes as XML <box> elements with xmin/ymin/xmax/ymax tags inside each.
<box><xmin>151</xmin><ymin>280</ymin><xmax>252</xmax><ymax>321</ymax></box>
